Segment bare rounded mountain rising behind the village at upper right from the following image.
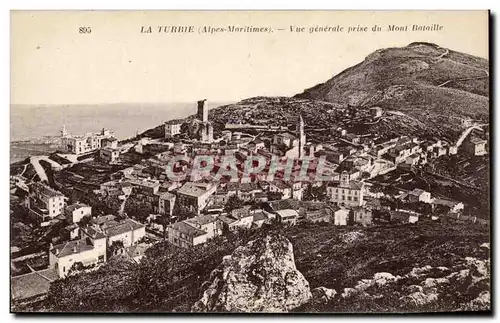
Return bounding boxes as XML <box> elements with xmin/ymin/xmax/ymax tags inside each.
<box><xmin>296</xmin><ymin>43</ymin><xmax>489</xmax><ymax>120</ymax></box>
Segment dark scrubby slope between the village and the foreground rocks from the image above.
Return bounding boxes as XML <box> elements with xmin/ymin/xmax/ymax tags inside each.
<box><xmin>22</xmin><ymin>223</ymin><xmax>489</xmax><ymax>312</ymax></box>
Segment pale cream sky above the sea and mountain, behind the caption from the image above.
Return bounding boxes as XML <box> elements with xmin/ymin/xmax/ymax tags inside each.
<box><xmin>11</xmin><ymin>11</ymin><xmax>488</xmax><ymax>104</ymax></box>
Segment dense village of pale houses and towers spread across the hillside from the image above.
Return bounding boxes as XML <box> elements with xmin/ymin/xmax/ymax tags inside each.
<box><xmin>10</xmin><ymin>100</ymin><xmax>489</xmax><ymax>302</ymax></box>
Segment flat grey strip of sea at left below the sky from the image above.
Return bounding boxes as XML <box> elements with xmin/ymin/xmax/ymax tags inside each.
<box><xmin>10</xmin><ymin>102</ymin><xmax>230</xmax><ymax>142</ymax></box>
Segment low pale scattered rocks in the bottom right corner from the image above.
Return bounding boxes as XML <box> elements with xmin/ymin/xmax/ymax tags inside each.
<box><xmin>340</xmin><ymin>257</ymin><xmax>490</xmax><ymax>311</ymax></box>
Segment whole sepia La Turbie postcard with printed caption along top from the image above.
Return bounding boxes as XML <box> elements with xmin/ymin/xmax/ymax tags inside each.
<box><xmin>10</xmin><ymin>11</ymin><xmax>492</xmax><ymax>313</ymax></box>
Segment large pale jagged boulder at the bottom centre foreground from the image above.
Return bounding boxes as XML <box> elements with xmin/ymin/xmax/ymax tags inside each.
<box><xmin>192</xmin><ymin>235</ymin><xmax>311</xmax><ymax>312</ymax></box>
